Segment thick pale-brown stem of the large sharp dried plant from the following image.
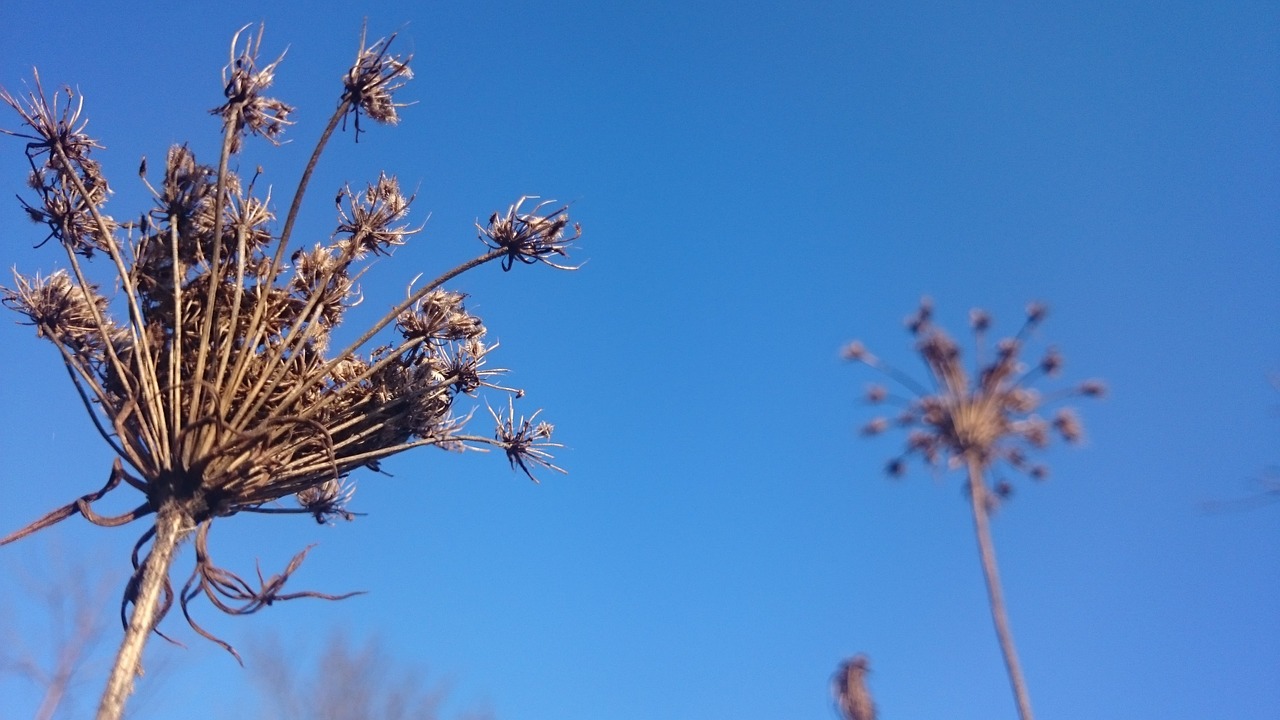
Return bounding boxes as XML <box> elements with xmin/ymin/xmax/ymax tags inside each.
<box><xmin>97</xmin><ymin>502</ymin><xmax>191</xmax><ymax>720</ymax></box>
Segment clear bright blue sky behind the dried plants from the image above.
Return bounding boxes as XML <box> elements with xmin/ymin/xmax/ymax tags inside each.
<box><xmin>0</xmin><ymin>1</ymin><xmax>1280</xmax><ymax>720</ymax></box>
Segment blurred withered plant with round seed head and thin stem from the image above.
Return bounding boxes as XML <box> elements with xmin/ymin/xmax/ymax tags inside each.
<box><xmin>844</xmin><ymin>299</ymin><xmax>1105</xmax><ymax>720</ymax></box>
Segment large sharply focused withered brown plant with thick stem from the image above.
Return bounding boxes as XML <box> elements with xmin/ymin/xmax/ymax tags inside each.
<box><xmin>0</xmin><ymin>23</ymin><xmax>579</xmax><ymax>717</ymax></box>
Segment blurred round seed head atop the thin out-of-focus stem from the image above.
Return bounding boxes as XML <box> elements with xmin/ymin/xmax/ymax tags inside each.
<box><xmin>844</xmin><ymin>299</ymin><xmax>1105</xmax><ymax>495</ymax></box>
